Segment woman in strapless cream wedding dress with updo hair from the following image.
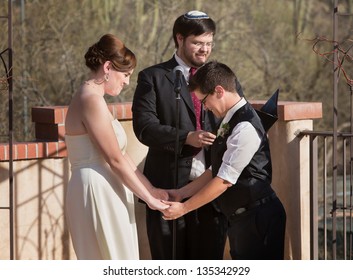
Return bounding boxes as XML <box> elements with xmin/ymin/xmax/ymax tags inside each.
<box><xmin>65</xmin><ymin>34</ymin><xmax>168</xmax><ymax>260</ymax></box>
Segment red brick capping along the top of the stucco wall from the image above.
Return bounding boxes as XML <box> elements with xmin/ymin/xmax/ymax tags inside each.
<box><xmin>0</xmin><ymin>100</ymin><xmax>322</xmax><ymax>161</ymax></box>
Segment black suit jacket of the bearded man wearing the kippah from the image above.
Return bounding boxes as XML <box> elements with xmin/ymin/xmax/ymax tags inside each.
<box><xmin>132</xmin><ymin>57</ymin><xmax>219</xmax><ymax>188</ymax></box>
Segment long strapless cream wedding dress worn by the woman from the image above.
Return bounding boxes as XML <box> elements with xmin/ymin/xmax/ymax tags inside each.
<box><xmin>65</xmin><ymin>120</ymin><xmax>139</xmax><ymax>260</ymax></box>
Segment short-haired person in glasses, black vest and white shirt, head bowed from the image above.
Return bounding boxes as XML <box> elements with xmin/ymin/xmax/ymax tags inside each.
<box><xmin>163</xmin><ymin>61</ymin><xmax>286</xmax><ymax>260</ymax></box>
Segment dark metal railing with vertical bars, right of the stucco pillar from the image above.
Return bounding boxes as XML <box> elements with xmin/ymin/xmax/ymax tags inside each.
<box><xmin>300</xmin><ymin>131</ymin><xmax>353</xmax><ymax>260</ymax></box>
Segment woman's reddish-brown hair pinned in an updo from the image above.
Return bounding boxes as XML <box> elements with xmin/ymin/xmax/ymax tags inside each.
<box><xmin>85</xmin><ymin>34</ymin><xmax>136</xmax><ymax>72</ymax></box>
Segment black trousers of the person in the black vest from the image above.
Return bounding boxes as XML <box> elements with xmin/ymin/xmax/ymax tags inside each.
<box><xmin>228</xmin><ymin>198</ymin><xmax>286</xmax><ymax>260</ymax></box>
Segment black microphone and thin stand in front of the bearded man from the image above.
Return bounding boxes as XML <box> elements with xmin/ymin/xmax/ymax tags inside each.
<box><xmin>172</xmin><ymin>79</ymin><xmax>181</xmax><ymax>260</ymax></box>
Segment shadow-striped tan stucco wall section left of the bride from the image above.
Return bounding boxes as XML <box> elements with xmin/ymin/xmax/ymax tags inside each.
<box><xmin>0</xmin><ymin>158</ymin><xmax>74</xmax><ymax>259</ymax></box>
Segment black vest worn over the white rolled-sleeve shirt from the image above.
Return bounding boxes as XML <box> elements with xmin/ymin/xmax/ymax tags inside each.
<box><xmin>211</xmin><ymin>103</ymin><xmax>273</xmax><ymax>217</ymax></box>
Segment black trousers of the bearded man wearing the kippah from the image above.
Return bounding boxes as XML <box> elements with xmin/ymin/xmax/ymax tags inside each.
<box><xmin>146</xmin><ymin>203</ymin><xmax>227</xmax><ymax>260</ymax></box>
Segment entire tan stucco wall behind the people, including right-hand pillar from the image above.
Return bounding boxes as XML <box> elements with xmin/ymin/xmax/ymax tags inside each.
<box><xmin>0</xmin><ymin>120</ymin><xmax>312</xmax><ymax>259</ymax></box>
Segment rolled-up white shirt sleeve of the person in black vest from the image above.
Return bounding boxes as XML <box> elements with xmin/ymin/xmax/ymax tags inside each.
<box><xmin>217</xmin><ymin>122</ymin><xmax>261</xmax><ymax>185</ymax></box>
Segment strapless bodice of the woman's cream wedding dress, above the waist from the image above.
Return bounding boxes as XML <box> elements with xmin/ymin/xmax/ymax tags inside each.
<box><xmin>65</xmin><ymin>119</ymin><xmax>127</xmax><ymax>168</ymax></box>
